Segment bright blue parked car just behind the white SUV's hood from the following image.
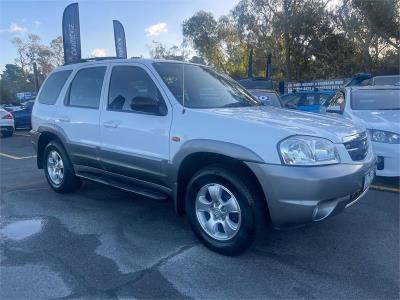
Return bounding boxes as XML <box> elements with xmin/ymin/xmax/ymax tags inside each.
<box><xmin>281</xmin><ymin>90</ymin><xmax>335</xmax><ymax>112</ymax></box>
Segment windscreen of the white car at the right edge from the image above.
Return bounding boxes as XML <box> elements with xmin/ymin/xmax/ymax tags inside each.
<box><xmin>351</xmin><ymin>90</ymin><xmax>400</xmax><ymax>110</ymax></box>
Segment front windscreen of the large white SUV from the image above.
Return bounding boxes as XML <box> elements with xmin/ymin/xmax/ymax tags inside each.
<box><xmin>153</xmin><ymin>62</ymin><xmax>262</xmax><ymax>108</ymax></box>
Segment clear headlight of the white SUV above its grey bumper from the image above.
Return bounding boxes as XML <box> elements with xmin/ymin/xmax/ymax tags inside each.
<box><xmin>278</xmin><ymin>136</ymin><xmax>340</xmax><ymax>166</ymax></box>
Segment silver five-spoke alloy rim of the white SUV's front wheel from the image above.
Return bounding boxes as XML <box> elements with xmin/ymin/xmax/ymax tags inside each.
<box><xmin>196</xmin><ymin>183</ymin><xmax>241</xmax><ymax>241</ymax></box>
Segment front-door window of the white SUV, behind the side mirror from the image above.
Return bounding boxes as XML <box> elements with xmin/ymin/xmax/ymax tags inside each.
<box><xmin>108</xmin><ymin>66</ymin><xmax>166</xmax><ymax>114</ymax></box>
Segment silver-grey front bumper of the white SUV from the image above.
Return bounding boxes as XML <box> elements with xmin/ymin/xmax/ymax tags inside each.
<box><xmin>247</xmin><ymin>157</ymin><xmax>376</xmax><ymax>228</ymax></box>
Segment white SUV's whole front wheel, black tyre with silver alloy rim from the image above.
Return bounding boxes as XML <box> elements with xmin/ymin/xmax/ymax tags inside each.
<box><xmin>185</xmin><ymin>165</ymin><xmax>266</xmax><ymax>255</ymax></box>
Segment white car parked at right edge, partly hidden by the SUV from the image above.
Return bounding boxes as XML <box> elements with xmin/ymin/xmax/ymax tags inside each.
<box><xmin>325</xmin><ymin>86</ymin><xmax>400</xmax><ymax>176</ymax></box>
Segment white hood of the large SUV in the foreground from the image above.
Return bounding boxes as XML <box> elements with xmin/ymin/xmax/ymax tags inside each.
<box><xmin>207</xmin><ymin>106</ymin><xmax>364</xmax><ymax>143</ymax></box>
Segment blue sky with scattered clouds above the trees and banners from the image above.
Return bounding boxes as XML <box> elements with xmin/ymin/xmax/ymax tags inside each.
<box><xmin>0</xmin><ymin>0</ymin><xmax>238</xmax><ymax>72</ymax></box>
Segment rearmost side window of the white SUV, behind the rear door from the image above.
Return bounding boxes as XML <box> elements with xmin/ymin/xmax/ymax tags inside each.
<box><xmin>38</xmin><ymin>70</ymin><xmax>72</xmax><ymax>104</ymax></box>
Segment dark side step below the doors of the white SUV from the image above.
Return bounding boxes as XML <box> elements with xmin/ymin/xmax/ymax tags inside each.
<box><xmin>76</xmin><ymin>172</ymin><xmax>168</xmax><ymax>201</ymax></box>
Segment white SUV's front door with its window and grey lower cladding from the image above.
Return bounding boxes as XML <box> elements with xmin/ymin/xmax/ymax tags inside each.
<box><xmin>100</xmin><ymin>64</ymin><xmax>172</xmax><ymax>185</ymax></box>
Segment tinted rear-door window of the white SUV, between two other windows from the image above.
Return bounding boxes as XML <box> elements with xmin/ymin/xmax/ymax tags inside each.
<box><xmin>66</xmin><ymin>67</ymin><xmax>106</xmax><ymax>108</ymax></box>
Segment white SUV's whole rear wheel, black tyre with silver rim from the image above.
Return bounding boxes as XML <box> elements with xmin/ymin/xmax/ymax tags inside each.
<box><xmin>43</xmin><ymin>141</ymin><xmax>82</xmax><ymax>193</ymax></box>
